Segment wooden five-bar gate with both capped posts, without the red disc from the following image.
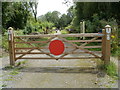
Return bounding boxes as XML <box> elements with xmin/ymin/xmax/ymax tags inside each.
<box><xmin>8</xmin><ymin>25</ymin><xmax>111</xmax><ymax>65</ymax></box>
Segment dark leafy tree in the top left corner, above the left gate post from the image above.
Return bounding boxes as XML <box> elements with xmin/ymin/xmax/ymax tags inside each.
<box><xmin>2</xmin><ymin>2</ymin><xmax>30</xmax><ymax>29</ymax></box>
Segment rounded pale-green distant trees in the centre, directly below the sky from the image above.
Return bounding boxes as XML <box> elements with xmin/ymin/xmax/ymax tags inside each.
<box><xmin>39</xmin><ymin>11</ymin><xmax>72</xmax><ymax>28</ymax></box>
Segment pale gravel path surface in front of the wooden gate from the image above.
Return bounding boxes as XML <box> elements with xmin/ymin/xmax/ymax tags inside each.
<box><xmin>1</xmin><ymin>31</ymin><xmax>117</xmax><ymax>88</ymax></box>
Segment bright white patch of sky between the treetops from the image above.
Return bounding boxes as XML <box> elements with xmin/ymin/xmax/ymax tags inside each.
<box><xmin>37</xmin><ymin>0</ymin><xmax>72</xmax><ymax>17</ymax></box>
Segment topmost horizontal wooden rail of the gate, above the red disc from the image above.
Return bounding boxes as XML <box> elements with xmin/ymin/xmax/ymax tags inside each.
<box><xmin>14</xmin><ymin>33</ymin><xmax>103</xmax><ymax>38</ymax></box>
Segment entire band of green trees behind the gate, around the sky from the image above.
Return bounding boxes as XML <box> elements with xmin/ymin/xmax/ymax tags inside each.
<box><xmin>2</xmin><ymin>0</ymin><xmax>120</xmax><ymax>32</ymax></box>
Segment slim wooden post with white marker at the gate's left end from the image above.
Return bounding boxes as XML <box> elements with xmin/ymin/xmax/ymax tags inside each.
<box><xmin>8</xmin><ymin>27</ymin><xmax>15</xmax><ymax>65</ymax></box>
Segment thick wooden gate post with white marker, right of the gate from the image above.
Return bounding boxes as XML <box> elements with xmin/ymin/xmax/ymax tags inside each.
<box><xmin>102</xmin><ymin>25</ymin><xmax>111</xmax><ymax>64</ymax></box>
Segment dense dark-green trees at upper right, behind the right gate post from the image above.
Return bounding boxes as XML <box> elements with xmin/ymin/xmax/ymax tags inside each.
<box><xmin>68</xmin><ymin>2</ymin><xmax>120</xmax><ymax>32</ymax></box>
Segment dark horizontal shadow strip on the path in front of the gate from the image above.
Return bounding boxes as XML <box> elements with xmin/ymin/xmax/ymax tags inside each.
<box><xmin>17</xmin><ymin>67</ymin><xmax>99</xmax><ymax>74</ymax></box>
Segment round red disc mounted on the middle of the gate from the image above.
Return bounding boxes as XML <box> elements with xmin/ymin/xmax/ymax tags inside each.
<box><xmin>49</xmin><ymin>40</ymin><xmax>64</xmax><ymax>55</ymax></box>
